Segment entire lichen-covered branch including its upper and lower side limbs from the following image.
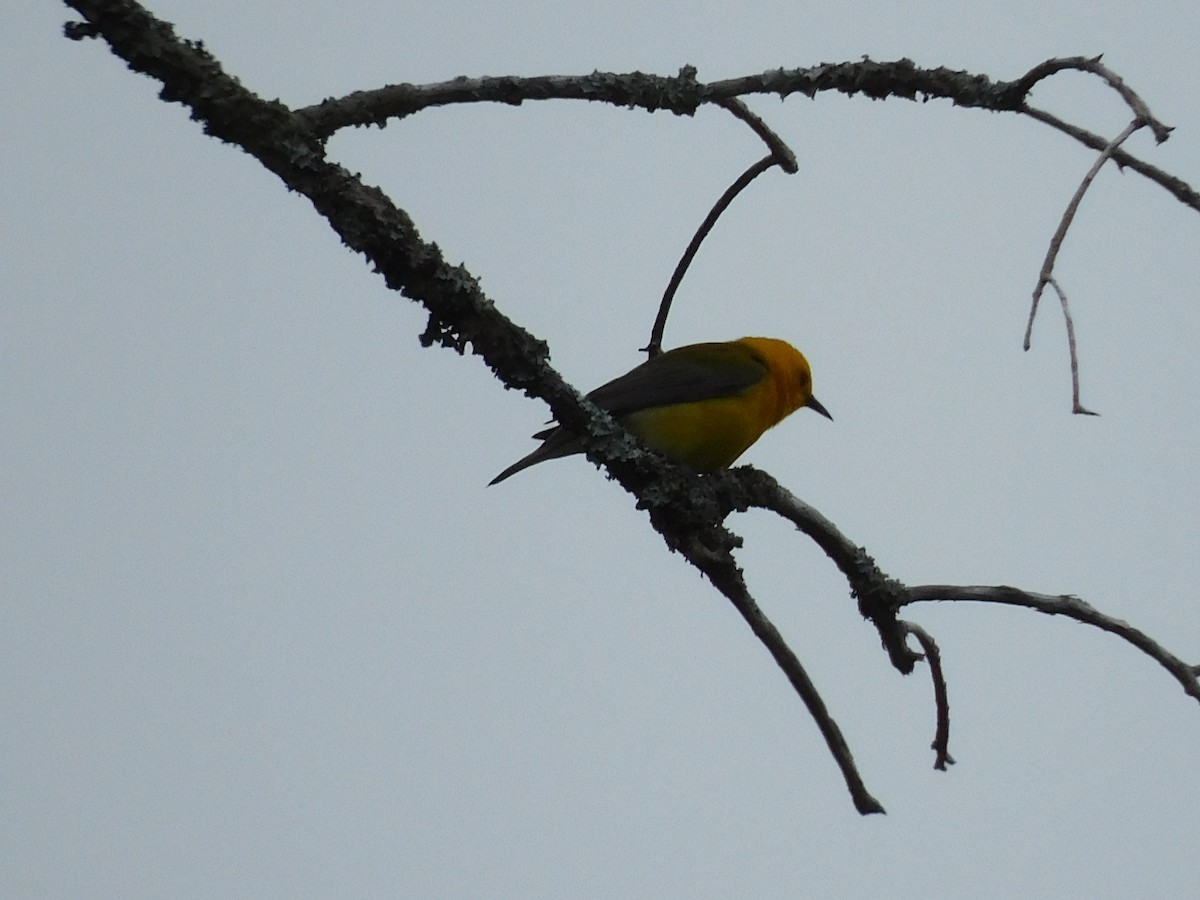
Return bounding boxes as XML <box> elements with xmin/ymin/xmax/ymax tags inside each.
<box><xmin>65</xmin><ymin>0</ymin><xmax>1200</xmax><ymax>812</ymax></box>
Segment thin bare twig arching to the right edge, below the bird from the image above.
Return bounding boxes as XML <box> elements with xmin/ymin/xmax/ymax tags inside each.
<box><xmin>902</xmin><ymin>584</ymin><xmax>1200</xmax><ymax>702</ymax></box>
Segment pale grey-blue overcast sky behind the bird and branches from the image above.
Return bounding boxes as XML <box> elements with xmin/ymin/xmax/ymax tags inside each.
<box><xmin>7</xmin><ymin>0</ymin><xmax>1200</xmax><ymax>898</ymax></box>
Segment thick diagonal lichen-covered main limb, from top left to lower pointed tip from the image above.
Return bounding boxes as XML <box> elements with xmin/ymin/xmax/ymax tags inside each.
<box><xmin>70</xmin><ymin>0</ymin><xmax>883</xmax><ymax>814</ymax></box>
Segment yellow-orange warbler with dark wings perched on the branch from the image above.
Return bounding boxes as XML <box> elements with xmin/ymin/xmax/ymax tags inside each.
<box><xmin>491</xmin><ymin>337</ymin><xmax>833</xmax><ymax>485</ymax></box>
